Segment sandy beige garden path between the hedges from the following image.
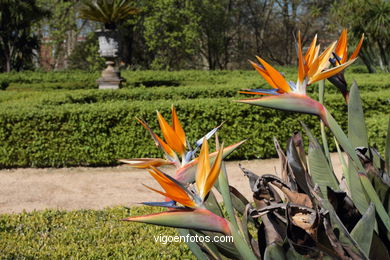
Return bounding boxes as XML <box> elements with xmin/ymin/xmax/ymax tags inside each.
<box><xmin>0</xmin><ymin>154</ymin><xmax>341</xmax><ymax>214</ymax></box>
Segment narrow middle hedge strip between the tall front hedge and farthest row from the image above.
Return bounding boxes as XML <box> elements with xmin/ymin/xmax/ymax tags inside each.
<box><xmin>0</xmin><ymin>77</ymin><xmax>390</xmax><ymax>106</ymax></box>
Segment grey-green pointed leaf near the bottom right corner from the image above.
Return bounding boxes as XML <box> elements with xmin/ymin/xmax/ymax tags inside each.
<box><xmin>351</xmin><ymin>203</ymin><xmax>375</xmax><ymax>256</ymax></box>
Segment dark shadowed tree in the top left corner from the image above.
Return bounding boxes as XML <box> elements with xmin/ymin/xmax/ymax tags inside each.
<box><xmin>0</xmin><ymin>0</ymin><xmax>49</xmax><ymax>72</ymax></box>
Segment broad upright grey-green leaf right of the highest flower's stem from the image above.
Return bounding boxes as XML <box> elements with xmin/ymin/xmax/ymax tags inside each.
<box><xmin>348</xmin><ymin>81</ymin><xmax>368</xmax><ymax>148</ymax></box>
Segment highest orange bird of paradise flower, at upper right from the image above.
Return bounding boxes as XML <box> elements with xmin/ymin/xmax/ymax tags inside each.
<box><xmin>238</xmin><ymin>32</ymin><xmax>363</xmax><ymax>123</ymax></box>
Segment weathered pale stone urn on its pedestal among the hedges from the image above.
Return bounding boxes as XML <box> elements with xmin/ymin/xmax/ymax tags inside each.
<box><xmin>96</xmin><ymin>30</ymin><xmax>125</xmax><ymax>89</ymax></box>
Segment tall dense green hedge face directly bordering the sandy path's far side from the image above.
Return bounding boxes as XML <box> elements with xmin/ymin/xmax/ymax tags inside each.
<box><xmin>0</xmin><ymin>90</ymin><xmax>390</xmax><ymax>167</ymax></box>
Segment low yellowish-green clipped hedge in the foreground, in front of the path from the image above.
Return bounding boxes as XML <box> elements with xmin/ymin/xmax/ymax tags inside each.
<box><xmin>0</xmin><ymin>207</ymin><xmax>196</xmax><ymax>259</ymax></box>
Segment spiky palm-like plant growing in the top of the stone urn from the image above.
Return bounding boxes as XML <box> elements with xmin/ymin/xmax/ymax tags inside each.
<box><xmin>80</xmin><ymin>0</ymin><xmax>139</xmax><ymax>30</ymax></box>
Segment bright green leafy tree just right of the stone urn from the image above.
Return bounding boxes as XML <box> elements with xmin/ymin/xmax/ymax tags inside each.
<box><xmin>143</xmin><ymin>0</ymin><xmax>199</xmax><ymax>69</ymax></box>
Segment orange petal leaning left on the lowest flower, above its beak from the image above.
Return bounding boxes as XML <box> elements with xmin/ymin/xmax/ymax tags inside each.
<box><xmin>148</xmin><ymin>167</ymin><xmax>195</xmax><ymax>207</ymax></box>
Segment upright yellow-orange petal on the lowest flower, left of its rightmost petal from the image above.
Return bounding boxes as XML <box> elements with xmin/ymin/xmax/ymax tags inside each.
<box><xmin>195</xmin><ymin>138</ymin><xmax>210</xmax><ymax>198</ymax></box>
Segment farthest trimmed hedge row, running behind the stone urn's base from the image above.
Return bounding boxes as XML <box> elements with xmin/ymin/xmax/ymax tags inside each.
<box><xmin>0</xmin><ymin>67</ymin><xmax>390</xmax><ymax>93</ymax></box>
